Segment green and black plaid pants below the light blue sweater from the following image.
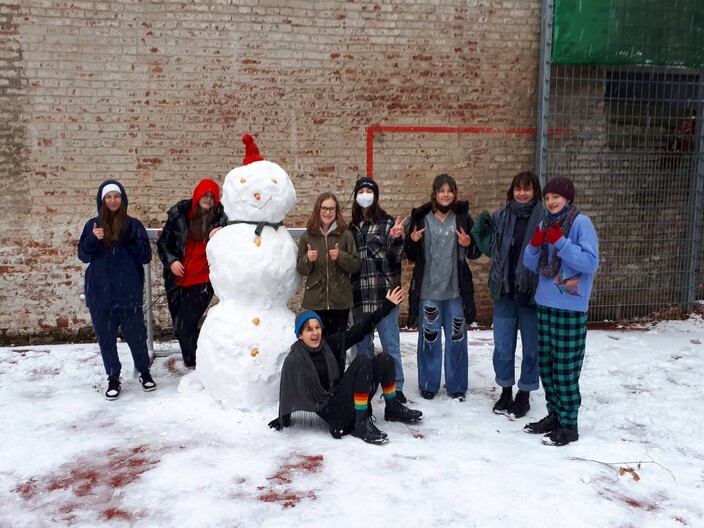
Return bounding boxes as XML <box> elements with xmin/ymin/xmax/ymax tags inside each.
<box><xmin>537</xmin><ymin>305</ymin><xmax>587</xmax><ymax>426</ymax></box>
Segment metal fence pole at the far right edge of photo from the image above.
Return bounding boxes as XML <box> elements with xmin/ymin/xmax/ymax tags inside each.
<box><xmin>684</xmin><ymin>70</ymin><xmax>704</xmax><ymax>310</ymax></box>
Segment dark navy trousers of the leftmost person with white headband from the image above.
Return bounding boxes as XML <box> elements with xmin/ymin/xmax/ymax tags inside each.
<box><xmin>89</xmin><ymin>306</ymin><xmax>150</xmax><ymax>378</ymax></box>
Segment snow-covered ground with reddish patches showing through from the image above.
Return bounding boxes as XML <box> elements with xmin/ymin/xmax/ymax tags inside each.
<box><xmin>0</xmin><ymin>316</ymin><xmax>704</xmax><ymax>528</ymax></box>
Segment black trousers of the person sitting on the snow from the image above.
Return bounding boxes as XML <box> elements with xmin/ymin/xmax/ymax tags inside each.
<box><xmin>319</xmin><ymin>352</ymin><xmax>396</xmax><ymax>434</ymax></box>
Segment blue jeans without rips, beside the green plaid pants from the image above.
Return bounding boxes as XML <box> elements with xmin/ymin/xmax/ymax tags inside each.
<box><xmin>494</xmin><ymin>297</ymin><xmax>538</xmax><ymax>391</ymax></box>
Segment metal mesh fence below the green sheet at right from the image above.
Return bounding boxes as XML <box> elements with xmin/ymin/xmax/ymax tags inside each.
<box><xmin>538</xmin><ymin>2</ymin><xmax>704</xmax><ymax>321</ymax></box>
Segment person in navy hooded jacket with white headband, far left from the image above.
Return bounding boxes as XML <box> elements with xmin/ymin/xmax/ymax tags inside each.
<box><xmin>78</xmin><ymin>180</ymin><xmax>156</xmax><ymax>400</ymax></box>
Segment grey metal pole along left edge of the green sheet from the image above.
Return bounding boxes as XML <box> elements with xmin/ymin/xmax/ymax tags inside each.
<box><xmin>535</xmin><ymin>0</ymin><xmax>555</xmax><ymax>185</ymax></box>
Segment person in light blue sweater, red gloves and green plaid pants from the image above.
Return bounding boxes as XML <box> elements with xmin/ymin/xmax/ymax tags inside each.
<box><xmin>523</xmin><ymin>177</ymin><xmax>599</xmax><ymax>446</ymax></box>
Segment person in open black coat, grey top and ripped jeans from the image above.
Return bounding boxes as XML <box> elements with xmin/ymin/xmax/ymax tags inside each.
<box><xmin>405</xmin><ymin>174</ymin><xmax>481</xmax><ymax>401</ymax></box>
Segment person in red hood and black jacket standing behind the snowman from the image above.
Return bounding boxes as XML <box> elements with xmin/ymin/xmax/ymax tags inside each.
<box><xmin>156</xmin><ymin>179</ymin><xmax>227</xmax><ymax>369</ymax></box>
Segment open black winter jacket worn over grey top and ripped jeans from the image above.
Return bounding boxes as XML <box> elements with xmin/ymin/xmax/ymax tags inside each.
<box><xmin>404</xmin><ymin>201</ymin><xmax>482</xmax><ymax>328</ymax></box>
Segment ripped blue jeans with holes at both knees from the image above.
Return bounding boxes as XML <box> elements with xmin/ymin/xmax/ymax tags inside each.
<box><xmin>418</xmin><ymin>297</ymin><xmax>469</xmax><ymax>394</ymax></box>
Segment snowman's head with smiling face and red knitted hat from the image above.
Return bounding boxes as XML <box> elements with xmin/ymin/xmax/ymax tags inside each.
<box><xmin>222</xmin><ymin>134</ymin><xmax>296</xmax><ymax>223</ymax></box>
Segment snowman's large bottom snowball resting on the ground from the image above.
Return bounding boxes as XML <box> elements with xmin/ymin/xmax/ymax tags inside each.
<box><xmin>197</xmin><ymin>301</ymin><xmax>296</xmax><ymax>410</ymax></box>
